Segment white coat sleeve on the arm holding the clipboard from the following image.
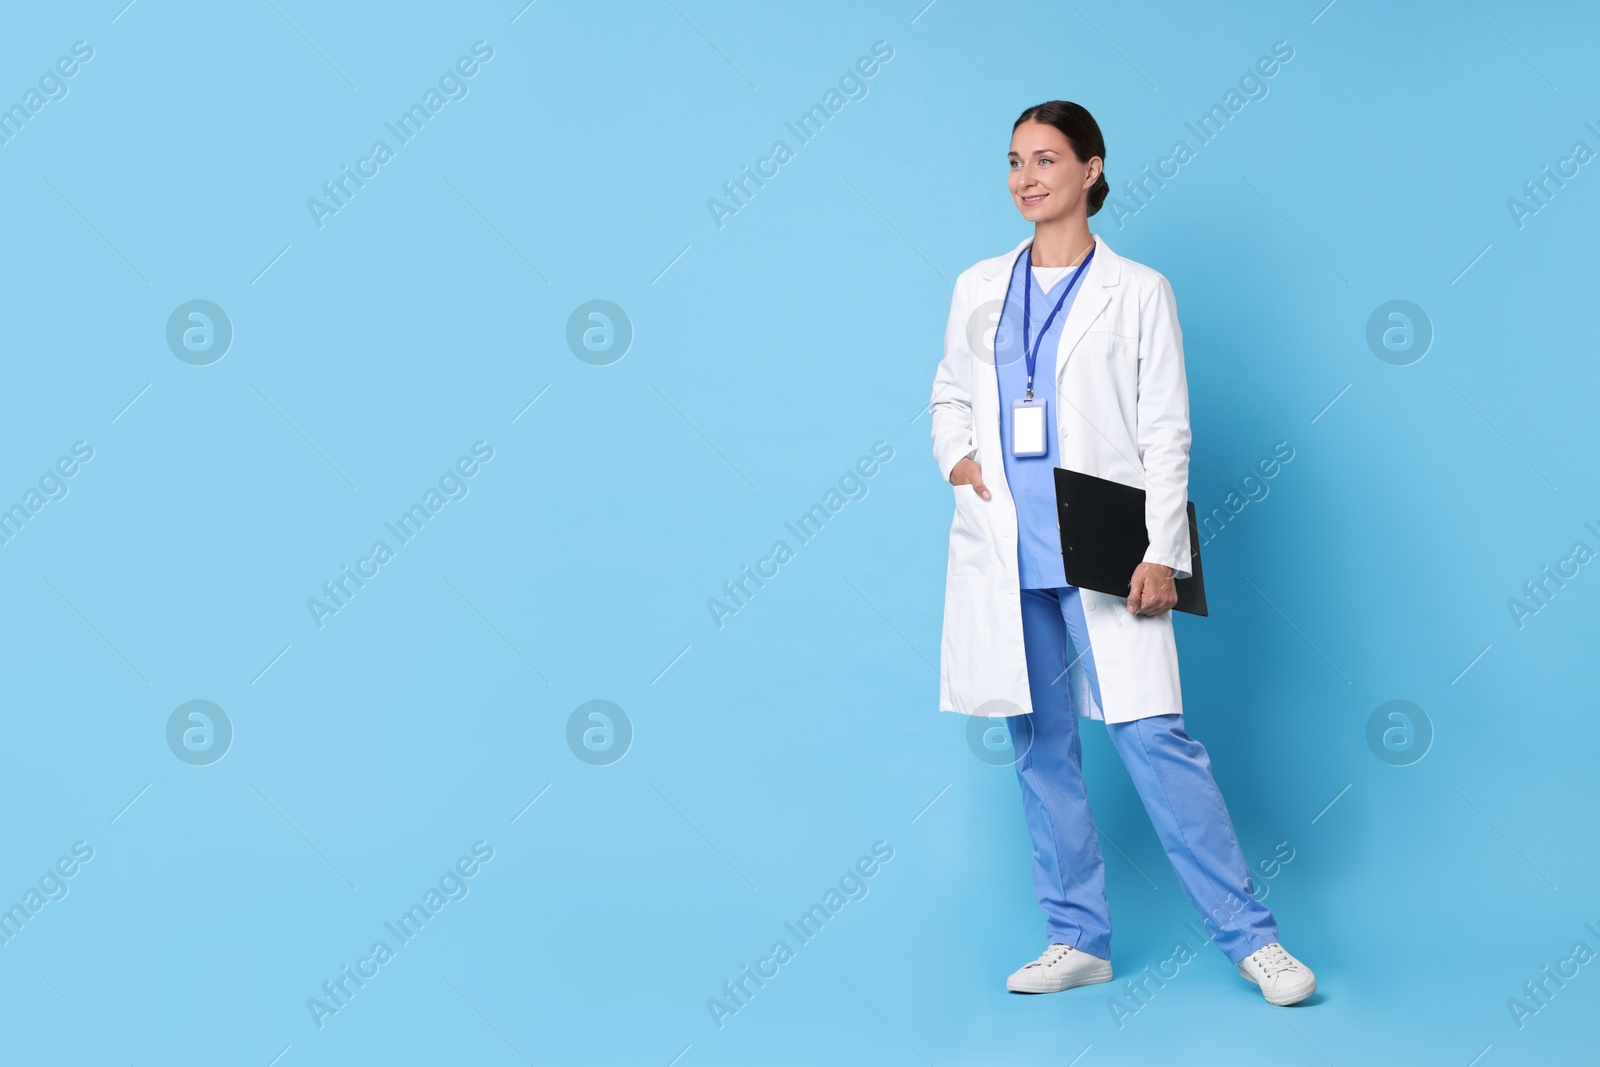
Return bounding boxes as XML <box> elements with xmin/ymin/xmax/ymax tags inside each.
<box><xmin>1138</xmin><ymin>274</ymin><xmax>1190</xmax><ymax>577</ymax></box>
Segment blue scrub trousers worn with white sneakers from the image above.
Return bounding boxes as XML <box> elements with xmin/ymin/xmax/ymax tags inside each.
<box><xmin>1006</xmin><ymin>585</ymin><xmax>1278</xmax><ymax>963</ymax></box>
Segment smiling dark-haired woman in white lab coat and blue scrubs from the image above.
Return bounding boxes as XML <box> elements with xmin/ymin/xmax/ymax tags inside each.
<box><xmin>931</xmin><ymin>101</ymin><xmax>1317</xmax><ymax>1005</ymax></box>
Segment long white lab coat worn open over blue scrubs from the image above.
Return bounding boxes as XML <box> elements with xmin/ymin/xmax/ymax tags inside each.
<box><xmin>931</xmin><ymin>234</ymin><xmax>1190</xmax><ymax>723</ymax></box>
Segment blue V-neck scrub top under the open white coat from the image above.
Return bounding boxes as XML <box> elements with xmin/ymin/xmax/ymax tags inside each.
<box><xmin>995</xmin><ymin>245</ymin><xmax>1088</xmax><ymax>589</ymax></box>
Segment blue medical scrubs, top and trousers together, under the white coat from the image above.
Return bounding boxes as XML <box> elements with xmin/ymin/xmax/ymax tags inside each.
<box><xmin>995</xmin><ymin>246</ymin><xmax>1278</xmax><ymax>963</ymax></box>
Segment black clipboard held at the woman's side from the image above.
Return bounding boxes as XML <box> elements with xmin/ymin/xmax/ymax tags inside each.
<box><xmin>1056</xmin><ymin>467</ymin><xmax>1208</xmax><ymax>614</ymax></box>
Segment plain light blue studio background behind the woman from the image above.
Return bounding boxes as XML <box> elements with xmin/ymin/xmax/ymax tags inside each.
<box><xmin>0</xmin><ymin>0</ymin><xmax>1600</xmax><ymax>1067</ymax></box>
